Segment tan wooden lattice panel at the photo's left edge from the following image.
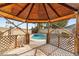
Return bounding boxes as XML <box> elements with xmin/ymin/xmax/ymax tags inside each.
<box><xmin>0</xmin><ymin>35</ymin><xmax>17</xmax><ymax>54</ymax></box>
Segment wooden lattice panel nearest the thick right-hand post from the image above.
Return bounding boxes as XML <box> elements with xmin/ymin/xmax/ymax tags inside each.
<box><xmin>60</xmin><ymin>35</ymin><xmax>74</xmax><ymax>53</ymax></box>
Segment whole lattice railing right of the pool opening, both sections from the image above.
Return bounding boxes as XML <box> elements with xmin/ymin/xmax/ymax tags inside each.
<box><xmin>50</xmin><ymin>30</ymin><xmax>75</xmax><ymax>53</ymax></box>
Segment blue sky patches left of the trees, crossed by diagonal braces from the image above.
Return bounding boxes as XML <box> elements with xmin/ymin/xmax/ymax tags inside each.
<box><xmin>0</xmin><ymin>18</ymin><xmax>36</xmax><ymax>29</ymax></box>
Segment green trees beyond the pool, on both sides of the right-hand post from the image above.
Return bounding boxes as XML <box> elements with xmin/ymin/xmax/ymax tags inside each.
<box><xmin>32</xmin><ymin>20</ymin><xmax>68</xmax><ymax>32</ymax></box>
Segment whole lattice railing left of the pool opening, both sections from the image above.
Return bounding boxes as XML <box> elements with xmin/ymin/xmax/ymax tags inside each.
<box><xmin>0</xmin><ymin>35</ymin><xmax>26</xmax><ymax>54</ymax></box>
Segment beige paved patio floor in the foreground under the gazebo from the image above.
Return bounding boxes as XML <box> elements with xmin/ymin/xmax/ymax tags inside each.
<box><xmin>4</xmin><ymin>44</ymin><xmax>75</xmax><ymax>56</ymax></box>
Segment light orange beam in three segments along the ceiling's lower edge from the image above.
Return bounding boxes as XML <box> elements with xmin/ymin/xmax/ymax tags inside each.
<box><xmin>0</xmin><ymin>11</ymin><xmax>75</xmax><ymax>23</ymax></box>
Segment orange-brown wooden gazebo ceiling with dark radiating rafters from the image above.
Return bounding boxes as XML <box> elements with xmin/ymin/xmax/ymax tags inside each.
<box><xmin>0</xmin><ymin>3</ymin><xmax>79</xmax><ymax>22</ymax></box>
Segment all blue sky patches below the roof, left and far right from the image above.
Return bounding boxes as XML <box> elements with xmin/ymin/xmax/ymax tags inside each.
<box><xmin>0</xmin><ymin>18</ymin><xmax>76</xmax><ymax>29</ymax></box>
